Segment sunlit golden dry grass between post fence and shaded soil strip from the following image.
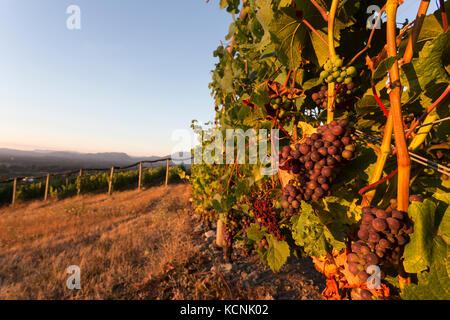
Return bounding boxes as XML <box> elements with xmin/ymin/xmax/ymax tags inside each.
<box><xmin>0</xmin><ymin>184</ymin><xmax>195</xmax><ymax>299</ymax></box>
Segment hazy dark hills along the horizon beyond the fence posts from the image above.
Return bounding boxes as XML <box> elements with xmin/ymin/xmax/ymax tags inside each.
<box><xmin>0</xmin><ymin>148</ymin><xmax>164</xmax><ymax>180</ymax></box>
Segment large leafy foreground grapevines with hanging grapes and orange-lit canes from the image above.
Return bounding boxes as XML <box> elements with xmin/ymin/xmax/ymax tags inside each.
<box><xmin>190</xmin><ymin>0</ymin><xmax>450</xmax><ymax>300</ymax></box>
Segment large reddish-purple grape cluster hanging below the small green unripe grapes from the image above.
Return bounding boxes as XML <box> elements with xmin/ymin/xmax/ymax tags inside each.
<box><xmin>280</xmin><ymin>119</ymin><xmax>355</xmax><ymax>208</ymax></box>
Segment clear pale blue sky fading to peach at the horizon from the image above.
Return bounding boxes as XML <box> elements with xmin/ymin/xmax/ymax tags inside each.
<box><xmin>0</xmin><ymin>0</ymin><xmax>436</xmax><ymax>156</ymax></box>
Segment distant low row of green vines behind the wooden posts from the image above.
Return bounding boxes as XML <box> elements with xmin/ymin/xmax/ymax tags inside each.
<box><xmin>0</xmin><ymin>167</ymin><xmax>186</xmax><ymax>205</ymax></box>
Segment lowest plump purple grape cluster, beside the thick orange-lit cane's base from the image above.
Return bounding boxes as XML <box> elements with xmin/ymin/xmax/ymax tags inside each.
<box><xmin>347</xmin><ymin>207</ymin><xmax>413</xmax><ymax>296</ymax></box>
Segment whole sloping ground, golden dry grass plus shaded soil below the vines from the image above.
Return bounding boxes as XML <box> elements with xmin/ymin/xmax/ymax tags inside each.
<box><xmin>0</xmin><ymin>184</ymin><xmax>323</xmax><ymax>299</ymax></box>
